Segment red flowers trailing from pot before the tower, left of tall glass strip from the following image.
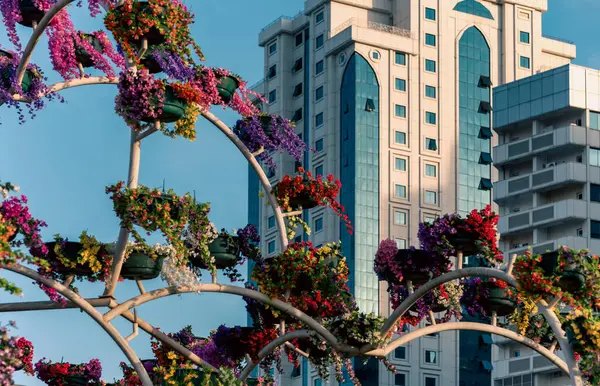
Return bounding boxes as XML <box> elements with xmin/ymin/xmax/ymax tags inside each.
<box><xmin>273</xmin><ymin>168</ymin><xmax>353</xmax><ymax>238</ymax></box>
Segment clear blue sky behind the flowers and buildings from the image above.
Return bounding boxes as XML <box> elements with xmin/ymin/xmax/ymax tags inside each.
<box><xmin>0</xmin><ymin>0</ymin><xmax>600</xmax><ymax>386</ymax></box>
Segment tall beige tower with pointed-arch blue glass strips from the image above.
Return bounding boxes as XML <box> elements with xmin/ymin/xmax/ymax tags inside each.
<box><xmin>249</xmin><ymin>0</ymin><xmax>575</xmax><ymax>386</ymax></box>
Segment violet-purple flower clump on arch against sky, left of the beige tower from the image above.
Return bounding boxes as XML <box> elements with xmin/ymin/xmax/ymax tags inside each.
<box><xmin>233</xmin><ymin>114</ymin><xmax>306</xmax><ymax>170</ymax></box>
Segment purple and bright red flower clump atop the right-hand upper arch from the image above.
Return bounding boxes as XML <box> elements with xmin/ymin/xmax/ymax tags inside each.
<box><xmin>418</xmin><ymin>205</ymin><xmax>503</xmax><ymax>265</ymax></box>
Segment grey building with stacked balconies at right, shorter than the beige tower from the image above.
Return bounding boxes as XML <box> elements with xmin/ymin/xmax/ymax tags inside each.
<box><xmin>493</xmin><ymin>65</ymin><xmax>600</xmax><ymax>386</ymax></box>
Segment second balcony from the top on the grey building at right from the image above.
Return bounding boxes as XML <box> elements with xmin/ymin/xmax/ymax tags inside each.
<box><xmin>494</xmin><ymin>162</ymin><xmax>587</xmax><ymax>203</ymax></box>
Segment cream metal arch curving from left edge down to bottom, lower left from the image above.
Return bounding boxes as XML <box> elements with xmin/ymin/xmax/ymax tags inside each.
<box><xmin>3</xmin><ymin>264</ymin><xmax>152</xmax><ymax>386</ymax></box>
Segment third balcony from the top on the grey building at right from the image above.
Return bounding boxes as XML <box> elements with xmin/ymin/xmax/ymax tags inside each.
<box><xmin>498</xmin><ymin>200</ymin><xmax>588</xmax><ymax>236</ymax></box>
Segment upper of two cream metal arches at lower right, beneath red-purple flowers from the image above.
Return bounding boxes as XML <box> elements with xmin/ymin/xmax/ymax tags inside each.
<box><xmin>381</xmin><ymin>267</ymin><xmax>517</xmax><ymax>335</ymax></box>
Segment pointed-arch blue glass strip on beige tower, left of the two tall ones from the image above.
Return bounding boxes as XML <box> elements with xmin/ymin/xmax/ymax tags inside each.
<box><xmin>340</xmin><ymin>53</ymin><xmax>379</xmax><ymax>316</ymax></box>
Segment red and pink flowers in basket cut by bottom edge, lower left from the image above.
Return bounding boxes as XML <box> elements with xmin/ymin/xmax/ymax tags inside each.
<box><xmin>35</xmin><ymin>358</ymin><xmax>102</xmax><ymax>386</ymax></box>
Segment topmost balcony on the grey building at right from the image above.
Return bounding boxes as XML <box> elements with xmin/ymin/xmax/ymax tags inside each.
<box><xmin>494</xmin><ymin>125</ymin><xmax>587</xmax><ymax>166</ymax></box>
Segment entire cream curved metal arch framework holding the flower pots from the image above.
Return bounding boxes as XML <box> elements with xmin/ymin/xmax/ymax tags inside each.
<box><xmin>0</xmin><ymin>0</ymin><xmax>583</xmax><ymax>386</ymax></box>
